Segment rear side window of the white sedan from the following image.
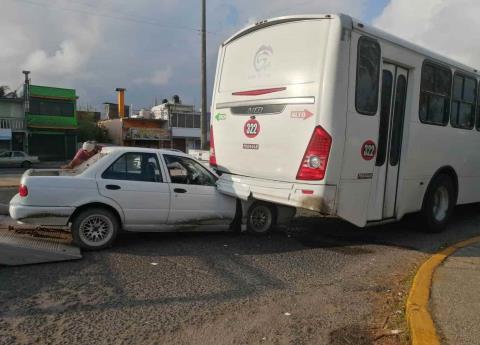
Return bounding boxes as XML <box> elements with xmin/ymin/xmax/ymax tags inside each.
<box><xmin>102</xmin><ymin>152</ymin><xmax>163</xmax><ymax>182</ymax></box>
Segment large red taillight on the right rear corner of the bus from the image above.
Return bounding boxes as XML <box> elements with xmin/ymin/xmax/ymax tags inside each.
<box><xmin>297</xmin><ymin>126</ymin><xmax>332</xmax><ymax>181</ymax></box>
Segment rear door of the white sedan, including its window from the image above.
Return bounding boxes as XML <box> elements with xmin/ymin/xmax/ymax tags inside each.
<box><xmin>97</xmin><ymin>152</ymin><xmax>170</xmax><ymax>230</ymax></box>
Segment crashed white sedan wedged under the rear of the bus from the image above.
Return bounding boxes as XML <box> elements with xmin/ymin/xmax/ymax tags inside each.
<box><xmin>10</xmin><ymin>147</ymin><xmax>248</xmax><ymax>250</ymax></box>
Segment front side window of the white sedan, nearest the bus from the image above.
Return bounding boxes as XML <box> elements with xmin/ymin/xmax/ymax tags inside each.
<box><xmin>163</xmin><ymin>155</ymin><xmax>216</xmax><ymax>186</ymax></box>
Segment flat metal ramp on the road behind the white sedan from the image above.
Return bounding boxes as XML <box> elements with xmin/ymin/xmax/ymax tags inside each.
<box><xmin>0</xmin><ymin>229</ymin><xmax>82</xmax><ymax>266</ymax></box>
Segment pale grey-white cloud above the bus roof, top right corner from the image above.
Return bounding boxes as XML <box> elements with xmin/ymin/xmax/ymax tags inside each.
<box><xmin>374</xmin><ymin>0</ymin><xmax>480</xmax><ymax>67</ymax></box>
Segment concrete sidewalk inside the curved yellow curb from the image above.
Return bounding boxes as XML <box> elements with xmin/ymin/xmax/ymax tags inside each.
<box><xmin>430</xmin><ymin>243</ymin><xmax>480</xmax><ymax>345</ymax></box>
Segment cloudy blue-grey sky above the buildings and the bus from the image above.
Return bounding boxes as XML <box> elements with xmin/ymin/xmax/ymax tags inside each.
<box><xmin>0</xmin><ymin>0</ymin><xmax>480</xmax><ymax>110</ymax></box>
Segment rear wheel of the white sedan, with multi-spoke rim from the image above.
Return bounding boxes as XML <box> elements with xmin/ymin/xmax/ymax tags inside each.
<box><xmin>72</xmin><ymin>208</ymin><xmax>120</xmax><ymax>251</ymax></box>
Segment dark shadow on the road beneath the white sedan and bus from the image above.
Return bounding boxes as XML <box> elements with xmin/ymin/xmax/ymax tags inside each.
<box><xmin>111</xmin><ymin>204</ymin><xmax>480</xmax><ymax>256</ymax></box>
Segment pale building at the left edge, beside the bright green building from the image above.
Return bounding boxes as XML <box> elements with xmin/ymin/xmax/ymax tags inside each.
<box><xmin>0</xmin><ymin>93</ymin><xmax>28</xmax><ymax>152</ymax></box>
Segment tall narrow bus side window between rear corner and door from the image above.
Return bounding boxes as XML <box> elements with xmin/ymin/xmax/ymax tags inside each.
<box><xmin>355</xmin><ymin>36</ymin><xmax>381</xmax><ymax>115</ymax></box>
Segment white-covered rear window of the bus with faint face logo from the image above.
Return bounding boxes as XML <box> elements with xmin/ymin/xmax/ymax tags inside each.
<box><xmin>218</xmin><ymin>20</ymin><xmax>330</xmax><ymax>93</ymax></box>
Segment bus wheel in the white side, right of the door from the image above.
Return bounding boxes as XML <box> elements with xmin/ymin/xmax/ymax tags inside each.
<box><xmin>422</xmin><ymin>174</ymin><xmax>455</xmax><ymax>233</ymax></box>
